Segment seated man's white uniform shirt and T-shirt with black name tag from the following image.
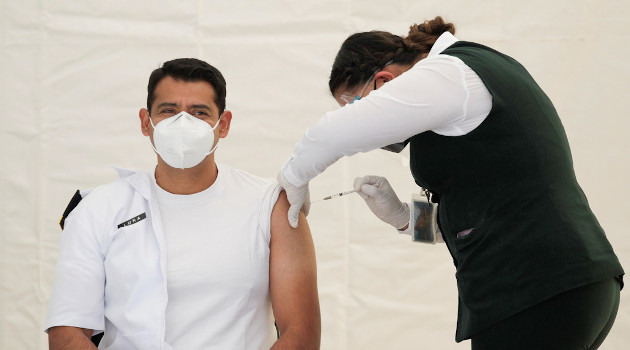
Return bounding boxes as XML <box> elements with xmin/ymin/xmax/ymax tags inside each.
<box><xmin>46</xmin><ymin>165</ymin><xmax>279</xmax><ymax>349</ymax></box>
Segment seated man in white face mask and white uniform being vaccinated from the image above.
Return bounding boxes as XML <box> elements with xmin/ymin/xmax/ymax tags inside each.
<box><xmin>46</xmin><ymin>58</ymin><xmax>320</xmax><ymax>350</ymax></box>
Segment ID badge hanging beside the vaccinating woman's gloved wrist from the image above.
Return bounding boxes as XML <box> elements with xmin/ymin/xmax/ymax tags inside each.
<box><xmin>412</xmin><ymin>193</ymin><xmax>442</xmax><ymax>244</ymax></box>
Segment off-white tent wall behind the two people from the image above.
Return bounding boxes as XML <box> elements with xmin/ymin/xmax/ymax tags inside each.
<box><xmin>0</xmin><ymin>0</ymin><xmax>630</xmax><ymax>350</ymax></box>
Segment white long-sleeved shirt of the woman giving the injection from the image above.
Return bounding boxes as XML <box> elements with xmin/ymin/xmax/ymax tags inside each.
<box><xmin>282</xmin><ymin>32</ymin><xmax>492</xmax><ymax>186</ymax></box>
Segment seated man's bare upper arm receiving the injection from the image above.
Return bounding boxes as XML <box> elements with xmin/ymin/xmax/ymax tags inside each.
<box><xmin>269</xmin><ymin>192</ymin><xmax>321</xmax><ymax>349</ymax></box>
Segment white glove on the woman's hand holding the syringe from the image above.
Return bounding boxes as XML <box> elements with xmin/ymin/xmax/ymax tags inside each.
<box><xmin>354</xmin><ymin>175</ymin><xmax>411</xmax><ymax>230</ymax></box>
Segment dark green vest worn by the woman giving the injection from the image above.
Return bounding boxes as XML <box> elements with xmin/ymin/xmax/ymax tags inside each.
<box><xmin>410</xmin><ymin>42</ymin><xmax>623</xmax><ymax>341</ymax></box>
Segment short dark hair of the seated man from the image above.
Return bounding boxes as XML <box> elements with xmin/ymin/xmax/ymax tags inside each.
<box><xmin>147</xmin><ymin>58</ymin><xmax>226</xmax><ymax>114</ymax></box>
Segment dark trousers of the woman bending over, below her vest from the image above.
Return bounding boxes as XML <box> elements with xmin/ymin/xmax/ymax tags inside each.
<box><xmin>471</xmin><ymin>278</ymin><xmax>621</xmax><ymax>350</ymax></box>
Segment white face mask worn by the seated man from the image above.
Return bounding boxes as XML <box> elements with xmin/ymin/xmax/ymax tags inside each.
<box><xmin>149</xmin><ymin>111</ymin><xmax>222</xmax><ymax>169</ymax></box>
